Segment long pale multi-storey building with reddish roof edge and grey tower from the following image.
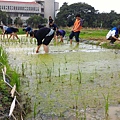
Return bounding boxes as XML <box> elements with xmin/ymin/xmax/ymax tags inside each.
<box><xmin>0</xmin><ymin>0</ymin><xmax>59</xmax><ymax>23</ymax></box>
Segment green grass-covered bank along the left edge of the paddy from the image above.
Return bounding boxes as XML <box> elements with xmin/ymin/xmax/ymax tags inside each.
<box><xmin>0</xmin><ymin>47</ymin><xmax>20</xmax><ymax>118</ymax></box>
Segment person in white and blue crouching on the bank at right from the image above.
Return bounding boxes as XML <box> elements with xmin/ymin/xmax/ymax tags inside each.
<box><xmin>106</xmin><ymin>25</ymin><xmax>120</xmax><ymax>44</ymax></box>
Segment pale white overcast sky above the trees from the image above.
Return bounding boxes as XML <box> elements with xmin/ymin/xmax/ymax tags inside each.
<box><xmin>55</xmin><ymin>0</ymin><xmax>120</xmax><ymax>13</ymax></box>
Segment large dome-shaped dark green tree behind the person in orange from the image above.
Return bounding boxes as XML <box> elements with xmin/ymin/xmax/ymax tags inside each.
<box><xmin>55</xmin><ymin>2</ymin><xmax>96</xmax><ymax>27</ymax></box>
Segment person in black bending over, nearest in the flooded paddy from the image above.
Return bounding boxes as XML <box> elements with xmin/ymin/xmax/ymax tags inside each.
<box><xmin>30</xmin><ymin>27</ymin><xmax>54</xmax><ymax>53</ymax></box>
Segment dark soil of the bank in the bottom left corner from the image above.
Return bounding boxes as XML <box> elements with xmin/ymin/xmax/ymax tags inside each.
<box><xmin>0</xmin><ymin>81</ymin><xmax>22</xmax><ymax>120</ymax></box>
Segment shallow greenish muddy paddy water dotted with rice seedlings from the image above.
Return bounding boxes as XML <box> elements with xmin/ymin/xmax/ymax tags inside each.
<box><xmin>1</xmin><ymin>37</ymin><xmax>120</xmax><ymax>120</ymax></box>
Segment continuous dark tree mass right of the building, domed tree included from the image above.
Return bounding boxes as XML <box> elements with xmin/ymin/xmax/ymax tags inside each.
<box><xmin>55</xmin><ymin>2</ymin><xmax>120</xmax><ymax>28</ymax></box>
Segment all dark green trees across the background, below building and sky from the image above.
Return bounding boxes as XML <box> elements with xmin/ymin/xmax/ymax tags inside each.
<box><xmin>0</xmin><ymin>2</ymin><xmax>120</xmax><ymax>28</ymax></box>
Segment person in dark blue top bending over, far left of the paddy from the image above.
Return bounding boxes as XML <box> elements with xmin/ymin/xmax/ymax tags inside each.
<box><xmin>4</xmin><ymin>27</ymin><xmax>19</xmax><ymax>39</ymax></box>
